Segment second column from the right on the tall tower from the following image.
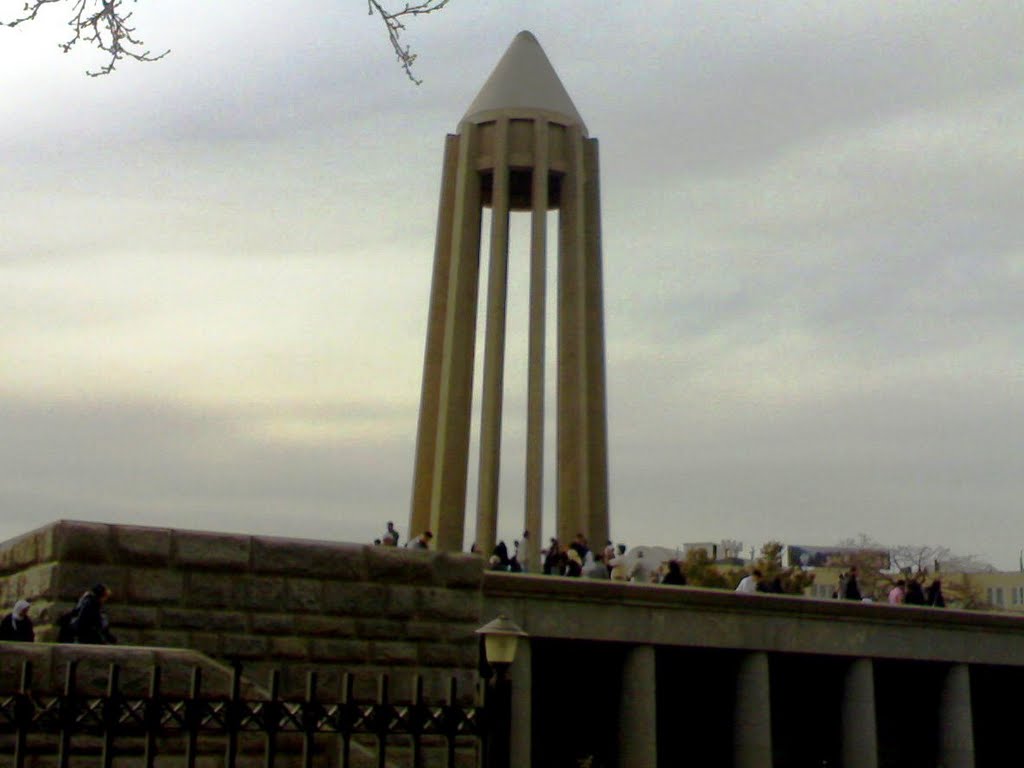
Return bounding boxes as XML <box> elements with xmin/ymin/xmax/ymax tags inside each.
<box><xmin>557</xmin><ymin>126</ymin><xmax>603</xmax><ymax>546</ymax></box>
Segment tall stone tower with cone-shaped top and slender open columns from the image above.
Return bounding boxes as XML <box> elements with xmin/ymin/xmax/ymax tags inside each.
<box><xmin>409</xmin><ymin>32</ymin><xmax>608</xmax><ymax>569</ymax></box>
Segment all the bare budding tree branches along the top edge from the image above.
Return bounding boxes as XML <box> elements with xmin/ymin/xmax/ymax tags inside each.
<box><xmin>0</xmin><ymin>0</ymin><xmax>449</xmax><ymax>78</ymax></box>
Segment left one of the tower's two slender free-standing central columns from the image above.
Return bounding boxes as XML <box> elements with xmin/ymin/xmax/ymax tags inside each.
<box><xmin>476</xmin><ymin>118</ymin><xmax>509</xmax><ymax>553</ymax></box>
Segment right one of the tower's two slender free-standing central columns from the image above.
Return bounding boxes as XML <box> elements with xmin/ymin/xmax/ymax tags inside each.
<box><xmin>523</xmin><ymin>120</ymin><xmax>548</xmax><ymax>573</ymax></box>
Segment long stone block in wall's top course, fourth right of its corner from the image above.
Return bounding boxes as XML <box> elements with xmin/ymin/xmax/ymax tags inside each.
<box><xmin>253</xmin><ymin>537</ymin><xmax>367</xmax><ymax>581</ymax></box>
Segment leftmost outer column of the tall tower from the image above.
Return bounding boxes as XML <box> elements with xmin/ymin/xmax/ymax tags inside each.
<box><xmin>406</xmin><ymin>134</ymin><xmax>459</xmax><ymax>540</ymax></box>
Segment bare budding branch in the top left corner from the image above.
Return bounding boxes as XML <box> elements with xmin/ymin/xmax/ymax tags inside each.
<box><xmin>7</xmin><ymin>0</ymin><xmax>171</xmax><ymax>77</ymax></box>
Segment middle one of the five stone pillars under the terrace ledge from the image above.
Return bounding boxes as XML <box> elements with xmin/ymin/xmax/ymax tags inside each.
<box><xmin>732</xmin><ymin>652</ymin><xmax>772</xmax><ymax>768</ymax></box>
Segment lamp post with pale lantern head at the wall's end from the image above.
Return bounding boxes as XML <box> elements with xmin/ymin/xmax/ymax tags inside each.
<box><xmin>476</xmin><ymin>614</ymin><xmax>529</xmax><ymax>768</ymax></box>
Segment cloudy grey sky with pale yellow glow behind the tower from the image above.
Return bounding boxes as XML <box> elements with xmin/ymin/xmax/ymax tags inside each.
<box><xmin>0</xmin><ymin>0</ymin><xmax>1024</xmax><ymax>568</ymax></box>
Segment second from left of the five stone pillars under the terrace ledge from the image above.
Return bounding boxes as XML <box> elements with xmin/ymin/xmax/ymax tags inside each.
<box><xmin>614</xmin><ymin>645</ymin><xmax>655</xmax><ymax>768</ymax></box>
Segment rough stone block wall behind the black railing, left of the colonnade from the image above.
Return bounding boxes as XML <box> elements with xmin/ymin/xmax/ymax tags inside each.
<box><xmin>0</xmin><ymin>521</ymin><xmax>483</xmax><ymax>696</ymax></box>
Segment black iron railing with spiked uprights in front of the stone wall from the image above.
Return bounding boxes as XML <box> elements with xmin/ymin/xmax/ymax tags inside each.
<box><xmin>0</xmin><ymin>662</ymin><xmax>484</xmax><ymax>768</ymax></box>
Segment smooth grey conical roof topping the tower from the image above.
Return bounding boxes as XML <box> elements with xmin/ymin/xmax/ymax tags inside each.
<box><xmin>462</xmin><ymin>31</ymin><xmax>587</xmax><ymax>134</ymax></box>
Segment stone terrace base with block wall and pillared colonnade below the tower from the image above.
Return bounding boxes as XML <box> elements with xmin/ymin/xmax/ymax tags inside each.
<box><xmin>0</xmin><ymin>521</ymin><xmax>1024</xmax><ymax>768</ymax></box>
